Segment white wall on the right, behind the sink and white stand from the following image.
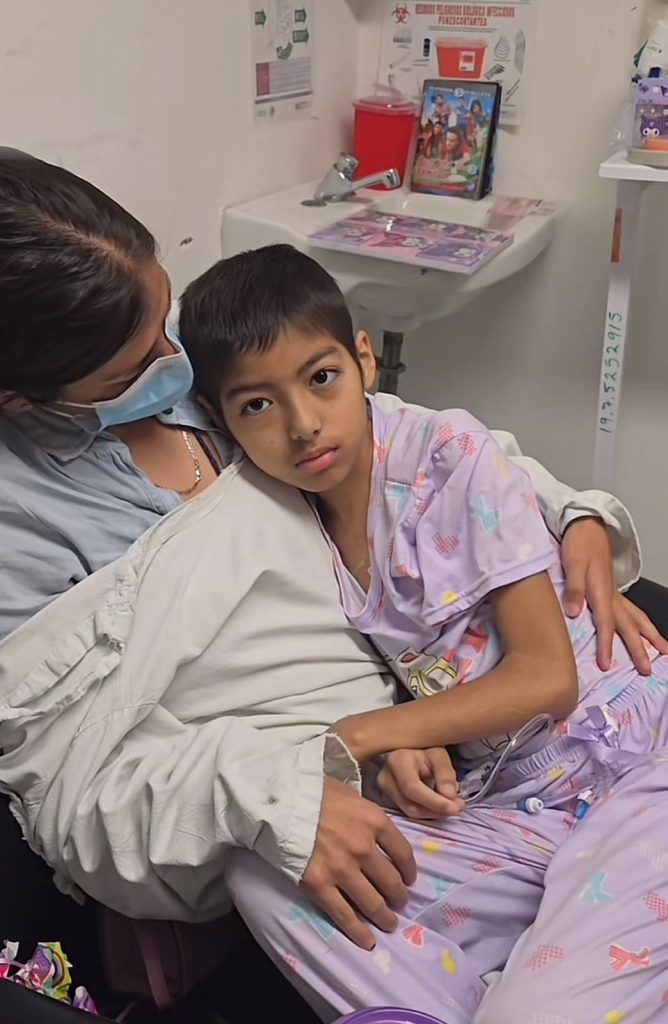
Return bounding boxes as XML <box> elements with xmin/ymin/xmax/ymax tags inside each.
<box><xmin>360</xmin><ymin>0</ymin><xmax>668</xmax><ymax>583</ymax></box>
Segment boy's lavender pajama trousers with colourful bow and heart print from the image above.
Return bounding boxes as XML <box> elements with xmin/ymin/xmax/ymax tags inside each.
<box><xmin>228</xmin><ymin>671</ymin><xmax>668</xmax><ymax>1024</ymax></box>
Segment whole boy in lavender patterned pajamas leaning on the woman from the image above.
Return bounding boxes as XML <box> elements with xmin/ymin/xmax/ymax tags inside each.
<box><xmin>180</xmin><ymin>246</ymin><xmax>668</xmax><ymax>1024</ymax></box>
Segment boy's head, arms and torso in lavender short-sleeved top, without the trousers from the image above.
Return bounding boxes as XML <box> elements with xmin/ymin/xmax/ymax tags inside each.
<box><xmin>180</xmin><ymin>246</ymin><xmax>658</xmax><ymax>802</ymax></box>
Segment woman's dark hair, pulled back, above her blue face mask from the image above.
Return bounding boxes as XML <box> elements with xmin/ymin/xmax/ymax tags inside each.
<box><xmin>0</xmin><ymin>147</ymin><xmax>156</xmax><ymax>400</ymax></box>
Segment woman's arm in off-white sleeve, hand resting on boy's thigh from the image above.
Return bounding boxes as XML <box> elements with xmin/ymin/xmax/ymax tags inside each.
<box><xmin>0</xmin><ymin>503</ymin><xmax>415</xmax><ymax>945</ymax></box>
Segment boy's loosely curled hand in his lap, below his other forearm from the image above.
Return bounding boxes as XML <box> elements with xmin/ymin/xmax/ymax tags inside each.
<box><xmin>378</xmin><ymin>746</ymin><xmax>465</xmax><ymax>820</ymax></box>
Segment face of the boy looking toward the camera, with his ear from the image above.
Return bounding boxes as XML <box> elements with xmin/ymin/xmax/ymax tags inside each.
<box><xmin>220</xmin><ymin>329</ymin><xmax>376</xmax><ymax>494</ymax></box>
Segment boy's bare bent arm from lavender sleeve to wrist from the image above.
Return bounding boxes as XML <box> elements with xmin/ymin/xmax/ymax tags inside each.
<box><xmin>334</xmin><ymin>572</ymin><xmax>578</xmax><ymax>761</ymax></box>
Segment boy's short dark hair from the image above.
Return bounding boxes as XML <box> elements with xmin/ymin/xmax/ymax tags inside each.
<box><xmin>179</xmin><ymin>245</ymin><xmax>358</xmax><ymax>409</ymax></box>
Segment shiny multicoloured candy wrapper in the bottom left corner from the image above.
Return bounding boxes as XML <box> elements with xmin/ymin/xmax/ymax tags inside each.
<box><xmin>0</xmin><ymin>940</ymin><xmax>97</xmax><ymax>1016</ymax></box>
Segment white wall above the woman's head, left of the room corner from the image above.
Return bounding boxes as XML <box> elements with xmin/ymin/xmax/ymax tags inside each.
<box><xmin>0</xmin><ymin>0</ymin><xmax>357</xmax><ymax>289</ymax></box>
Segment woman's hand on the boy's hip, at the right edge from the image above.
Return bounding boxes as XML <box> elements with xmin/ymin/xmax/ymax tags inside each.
<box><xmin>561</xmin><ymin>517</ymin><xmax>668</xmax><ymax>676</ymax></box>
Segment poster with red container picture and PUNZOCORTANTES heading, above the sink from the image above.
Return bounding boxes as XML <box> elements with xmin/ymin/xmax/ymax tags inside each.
<box><xmin>380</xmin><ymin>0</ymin><xmax>534</xmax><ymax>125</ymax></box>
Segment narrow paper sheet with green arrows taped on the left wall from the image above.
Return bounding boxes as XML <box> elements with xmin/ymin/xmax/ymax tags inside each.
<box><xmin>249</xmin><ymin>0</ymin><xmax>314</xmax><ymax>123</ymax></box>
